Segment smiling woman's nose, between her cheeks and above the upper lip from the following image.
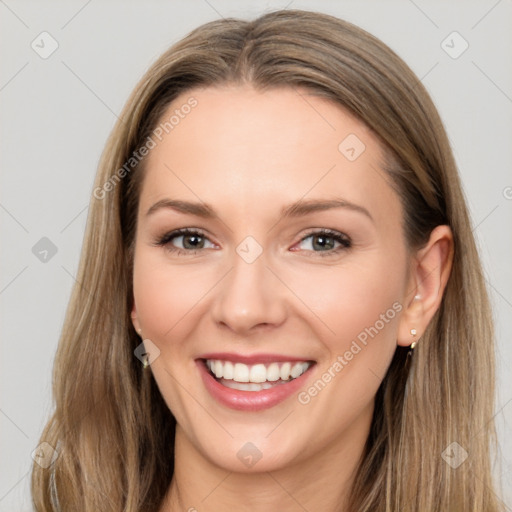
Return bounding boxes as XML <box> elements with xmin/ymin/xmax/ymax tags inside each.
<box><xmin>211</xmin><ymin>244</ymin><xmax>287</xmax><ymax>335</ymax></box>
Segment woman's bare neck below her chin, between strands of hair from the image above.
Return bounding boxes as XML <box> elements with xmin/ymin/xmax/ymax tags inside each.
<box><xmin>160</xmin><ymin>407</ymin><xmax>373</xmax><ymax>512</ymax></box>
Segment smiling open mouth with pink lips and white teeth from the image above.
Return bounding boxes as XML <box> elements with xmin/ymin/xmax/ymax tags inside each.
<box><xmin>196</xmin><ymin>355</ymin><xmax>315</xmax><ymax>411</ymax></box>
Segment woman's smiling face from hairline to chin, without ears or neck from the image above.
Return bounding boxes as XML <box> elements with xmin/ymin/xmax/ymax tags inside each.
<box><xmin>132</xmin><ymin>86</ymin><xmax>410</xmax><ymax>471</ymax></box>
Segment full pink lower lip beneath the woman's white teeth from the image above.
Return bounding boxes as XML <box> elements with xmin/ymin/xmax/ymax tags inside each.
<box><xmin>196</xmin><ymin>360</ymin><xmax>314</xmax><ymax>411</ymax></box>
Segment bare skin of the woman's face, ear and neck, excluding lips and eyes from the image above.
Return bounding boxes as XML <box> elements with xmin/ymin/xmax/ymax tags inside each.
<box><xmin>132</xmin><ymin>86</ymin><xmax>452</xmax><ymax>512</ymax></box>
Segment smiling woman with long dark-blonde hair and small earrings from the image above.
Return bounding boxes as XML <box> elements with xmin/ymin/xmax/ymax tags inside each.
<box><xmin>32</xmin><ymin>11</ymin><xmax>503</xmax><ymax>512</ymax></box>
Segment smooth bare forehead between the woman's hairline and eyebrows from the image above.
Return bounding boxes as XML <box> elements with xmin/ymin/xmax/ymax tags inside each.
<box><xmin>141</xmin><ymin>86</ymin><xmax>398</xmax><ymax>224</ymax></box>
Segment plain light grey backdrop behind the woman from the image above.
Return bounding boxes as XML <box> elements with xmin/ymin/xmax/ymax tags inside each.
<box><xmin>0</xmin><ymin>0</ymin><xmax>512</xmax><ymax>512</ymax></box>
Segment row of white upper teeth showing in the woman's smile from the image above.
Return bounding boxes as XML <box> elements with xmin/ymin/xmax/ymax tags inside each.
<box><xmin>206</xmin><ymin>359</ymin><xmax>311</xmax><ymax>383</ymax></box>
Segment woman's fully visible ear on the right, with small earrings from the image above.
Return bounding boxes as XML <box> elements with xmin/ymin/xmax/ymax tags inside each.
<box><xmin>397</xmin><ymin>226</ymin><xmax>453</xmax><ymax>347</ymax></box>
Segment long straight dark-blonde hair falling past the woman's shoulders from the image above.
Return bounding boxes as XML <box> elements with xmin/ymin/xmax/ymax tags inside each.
<box><xmin>32</xmin><ymin>10</ymin><xmax>502</xmax><ymax>512</ymax></box>
